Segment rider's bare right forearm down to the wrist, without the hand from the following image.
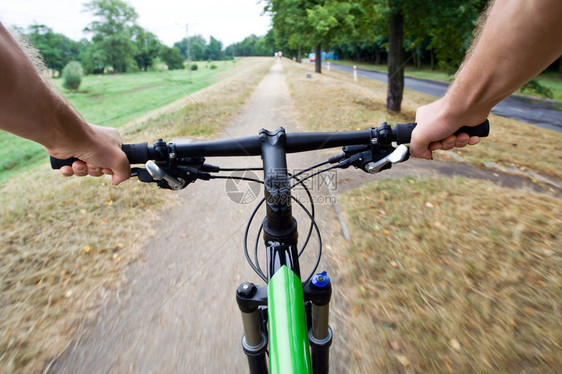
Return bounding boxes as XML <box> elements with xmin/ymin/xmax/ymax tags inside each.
<box><xmin>446</xmin><ymin>0</ymin><xmax>562</xmax><ymax>120</ymax></box>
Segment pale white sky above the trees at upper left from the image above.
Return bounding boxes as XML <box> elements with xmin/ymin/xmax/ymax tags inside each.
<box><xmin>0</xmin><ymin>0</ymin><xmax>271</xmax><ymax>47</ymax></box>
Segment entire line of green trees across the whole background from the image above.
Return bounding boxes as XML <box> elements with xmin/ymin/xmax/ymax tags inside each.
<box><xmin>19</xmin><ymin>0</ymin><xmax>562</xmax><ymax>106</ymax></box>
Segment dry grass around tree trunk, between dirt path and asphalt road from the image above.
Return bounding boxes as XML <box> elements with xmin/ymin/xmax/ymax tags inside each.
<box><xmin>284</xmin><ymin>61</ymin><xmax>562</xmax><ymax>179</ymax></box>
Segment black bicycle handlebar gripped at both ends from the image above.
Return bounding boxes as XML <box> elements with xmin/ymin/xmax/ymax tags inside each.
<box><xmin>51</xmin><ymin>120</ymin><xmax>490</xmax><ymax>169</ymax></box>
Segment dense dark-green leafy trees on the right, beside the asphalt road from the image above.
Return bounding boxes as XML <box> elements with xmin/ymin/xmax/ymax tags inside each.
<box><xmin>264</xmin><ymin>0</ymin><xmax>487</xmax><ymax>111</ymax></box>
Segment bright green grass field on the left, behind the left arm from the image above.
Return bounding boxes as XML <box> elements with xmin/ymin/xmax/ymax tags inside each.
<box><xmin>0</xmin><ymin>61</ymin><xmax>233</xmax><ymax>183</ymax></box>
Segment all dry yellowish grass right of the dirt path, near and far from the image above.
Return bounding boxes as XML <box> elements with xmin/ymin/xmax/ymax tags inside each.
<box><xmin>284</xmin><ymin>61</ymin><xmax>562</xmax><ymax>373</ymax></box>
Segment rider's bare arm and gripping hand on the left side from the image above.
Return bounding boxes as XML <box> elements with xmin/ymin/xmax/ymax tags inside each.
<box><xmin>0</xmin><ymin>23</ymin><xmax>131</xmax><ymax>184</ymax></box>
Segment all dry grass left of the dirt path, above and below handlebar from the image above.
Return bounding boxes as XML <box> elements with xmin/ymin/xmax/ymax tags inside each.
<box><xmin>0</xmin><ymin>58</ymin><xmax>274</xmax><ymax>373</ymax></box>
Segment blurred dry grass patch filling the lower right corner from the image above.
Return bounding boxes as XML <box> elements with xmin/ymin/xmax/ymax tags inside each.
<box><xmin>340</xmin><ymin>179</ymin><xmax>562</xmax><ymax>373</ymax></box>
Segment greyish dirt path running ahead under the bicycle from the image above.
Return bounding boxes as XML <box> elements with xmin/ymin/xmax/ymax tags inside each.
<box><xmin>51</xmin><ymin>62</ymin><xmax>352</xmax><ymax>373</ymax></box>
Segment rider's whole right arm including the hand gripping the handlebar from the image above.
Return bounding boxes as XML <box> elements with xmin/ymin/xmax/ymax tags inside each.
<box><xmin>410</xmin><ymin>0</ymin><xmax>562</xmax><ymax>159</ymax></box>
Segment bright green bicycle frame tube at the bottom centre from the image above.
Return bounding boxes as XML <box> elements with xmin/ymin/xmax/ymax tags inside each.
<box><xmin>267</xmin><ymin>265</ymin><xmax>312</xmax><ymax>374</ymax></box>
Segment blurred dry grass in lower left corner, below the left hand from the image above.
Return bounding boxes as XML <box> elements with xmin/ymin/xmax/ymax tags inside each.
<box><xmin>0</xmin><ymin>170</ymin><xmax>165</xmax><ymax>372</ymax></box>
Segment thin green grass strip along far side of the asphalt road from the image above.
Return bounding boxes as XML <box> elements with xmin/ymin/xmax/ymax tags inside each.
<box><xmin>331</xmin><ymin>60</ymin><xmax>562</xmax><ymax>101</ymax></box>
